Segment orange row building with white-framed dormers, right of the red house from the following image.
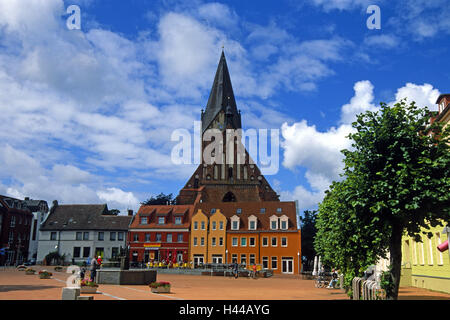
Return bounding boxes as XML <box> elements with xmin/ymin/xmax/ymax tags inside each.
<box><xmin>194</xmin><ymin>201</ymin><xmax>301</xmax><ymax>274</ymax></box>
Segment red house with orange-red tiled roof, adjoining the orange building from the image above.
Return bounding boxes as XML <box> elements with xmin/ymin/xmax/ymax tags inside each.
<box><xmin>128</xmin><ymin>205</ymin><xmax>194</xmax><ymax>263</ymax></box>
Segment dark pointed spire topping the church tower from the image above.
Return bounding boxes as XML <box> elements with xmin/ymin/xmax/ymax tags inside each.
<box><xmin>202</xmin><ymin>50</ymin><xmax>242</xmax><ymax>133</ymax></box>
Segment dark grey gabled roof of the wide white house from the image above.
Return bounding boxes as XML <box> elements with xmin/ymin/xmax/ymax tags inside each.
<box><xmin>41</xmin><ymin>204</ymin><xmax>132</xmax><ymax>231</ymax></box>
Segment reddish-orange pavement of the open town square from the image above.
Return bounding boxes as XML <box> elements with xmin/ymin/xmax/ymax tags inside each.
<box><xmin>0</xmin><ymin>266</ymin><xmax>450</xmax><ymax>300</ymax></box>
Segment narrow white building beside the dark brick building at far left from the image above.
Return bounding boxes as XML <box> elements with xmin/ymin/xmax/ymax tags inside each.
<box><xmin>23</xmin><ymin>198</ymin><xmax>48</xmax><ymax>260</ymax></box>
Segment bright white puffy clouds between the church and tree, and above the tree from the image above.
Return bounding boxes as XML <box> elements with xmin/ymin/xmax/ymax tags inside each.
<box><xmin>280</xmin><ymin>80</ymin><xmax>440</xmax><ymax>214</ymax></box>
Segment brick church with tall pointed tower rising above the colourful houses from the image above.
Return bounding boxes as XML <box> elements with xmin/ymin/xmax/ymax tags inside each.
<box><xmin>177</xmin><ymin>51</ymin><xmax>279</xmax><ymax>204</ymax></box>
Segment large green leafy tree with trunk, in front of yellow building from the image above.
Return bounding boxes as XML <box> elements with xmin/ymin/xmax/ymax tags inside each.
<box><xmin>316</xmin><ymin>100</ymin><xmax>450</xmax><ymax>299</ymax></box>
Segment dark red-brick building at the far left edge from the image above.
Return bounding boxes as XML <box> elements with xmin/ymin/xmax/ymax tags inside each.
<box><xmin>0</xmin><ymin>195</ymin><xmax>33</xmax><ymax>265</ymax></box>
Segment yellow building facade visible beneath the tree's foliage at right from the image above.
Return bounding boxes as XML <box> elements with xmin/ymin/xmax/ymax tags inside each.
<box><xmin>400</xmin><ymin>223</ymin><xmax>450</xmax><ymax>293</ymax></box>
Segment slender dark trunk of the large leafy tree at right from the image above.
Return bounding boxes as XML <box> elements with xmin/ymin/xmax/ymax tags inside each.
<box><xmin>386</xmin><ymin>223</ymin><xmax>403</xmax><ymax>300</ymax></box>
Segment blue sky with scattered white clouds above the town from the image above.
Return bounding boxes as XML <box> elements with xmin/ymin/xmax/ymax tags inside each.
<box><xmin>0</xmin><ymin>0</ymin><xmax>450</xmax><ymax>214</ymax></box>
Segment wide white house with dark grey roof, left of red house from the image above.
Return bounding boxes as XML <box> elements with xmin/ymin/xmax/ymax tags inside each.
<box><xmin>37</xmin><ymin>202</ymin><xmax>132</xmax><ymax>263</ymax></box>
